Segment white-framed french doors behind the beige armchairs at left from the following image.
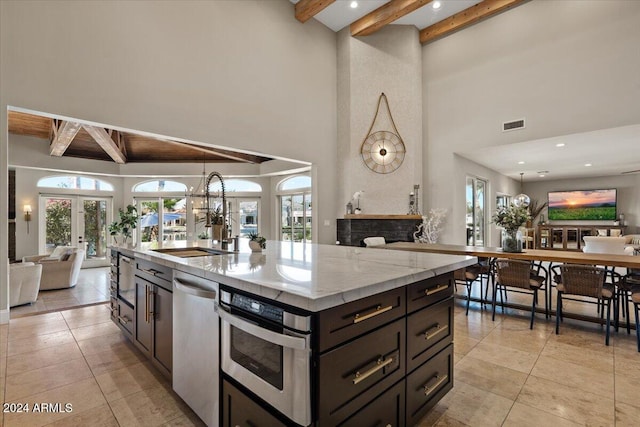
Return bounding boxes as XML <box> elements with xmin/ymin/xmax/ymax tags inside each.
<box><xmin>38</xmin><ymin>195</ymin><xmax>112</xmax><ymax>268</ymax></box>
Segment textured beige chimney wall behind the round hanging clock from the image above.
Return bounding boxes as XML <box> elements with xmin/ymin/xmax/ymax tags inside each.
<box><xmin>337</xmin><ymin>25</ymin><xmax>422</xmax><ymax>217</ymax></box>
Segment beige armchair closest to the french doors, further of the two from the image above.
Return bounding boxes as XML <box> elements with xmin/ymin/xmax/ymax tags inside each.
<box><xmin>22</xmin><ymin>246</ymin><xmax>84</xmax><ymax>291</ymax></box>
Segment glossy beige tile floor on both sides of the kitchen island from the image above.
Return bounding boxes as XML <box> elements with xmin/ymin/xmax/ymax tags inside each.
<box><xmin>0</xmin><ymin>300</ymin><xmax>640</xmax><ymax>427</ymax></box>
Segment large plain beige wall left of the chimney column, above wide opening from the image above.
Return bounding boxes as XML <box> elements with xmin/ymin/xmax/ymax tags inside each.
<box><xmin>0</xmin><ymin>0</ymin><xmax>338</xmax><ymax>318</ymax></box>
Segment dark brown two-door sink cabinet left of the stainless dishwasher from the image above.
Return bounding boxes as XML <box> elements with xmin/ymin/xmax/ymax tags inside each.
<box><xmin>134</xmin><ymin>260</ymin><xmax>173</xmax><ymax>378</ymax></box>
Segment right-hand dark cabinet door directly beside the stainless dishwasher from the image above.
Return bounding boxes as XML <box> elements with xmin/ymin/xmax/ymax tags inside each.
<box><xmin>151</xmin><ymin>286</ymin><xmax>173</xmax><ymax>372</ymax></box>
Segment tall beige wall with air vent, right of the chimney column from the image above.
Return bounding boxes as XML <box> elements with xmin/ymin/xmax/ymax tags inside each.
<box><xmin>422</xmin><ymin>0</ymin><xmax>640</xmax><ymax>243</ymax></box>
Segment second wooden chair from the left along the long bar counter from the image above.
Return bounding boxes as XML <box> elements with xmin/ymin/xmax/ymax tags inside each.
<box><xmin>491</xmin><ymin>258</ymin><xmax>546</xmax><ymax>329</ymax></box>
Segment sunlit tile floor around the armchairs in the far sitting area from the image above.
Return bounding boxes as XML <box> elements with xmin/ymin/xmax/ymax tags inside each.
<box><xmin>11</xmin><ymin>267</ymin><xmax>110</xmax><ymax>318</ymax></box>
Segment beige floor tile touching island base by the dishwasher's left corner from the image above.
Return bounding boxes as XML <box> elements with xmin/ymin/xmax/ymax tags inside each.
<box><xmin>96</xmin><ymin>363</ymin><xmax>168</xmax><ymax>402</ymax></box>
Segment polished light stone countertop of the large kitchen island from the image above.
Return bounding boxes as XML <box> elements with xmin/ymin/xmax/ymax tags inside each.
<box><xmin>117</xmin><ymin>239</ymin><xmax>477</xmax><ymax>312</ymax></box>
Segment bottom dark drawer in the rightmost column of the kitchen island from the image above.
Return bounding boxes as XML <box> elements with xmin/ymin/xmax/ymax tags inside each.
<box><xmin>406</xmin><ymin>344</ymin><xmax>453</xmax><ymax>426</ymax></box>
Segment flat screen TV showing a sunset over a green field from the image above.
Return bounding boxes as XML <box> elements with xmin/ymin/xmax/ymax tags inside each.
<box><xmin>547</xmin><ymin>188</ymin><xmax>617</xmax><ymax>221</ymax></box>
